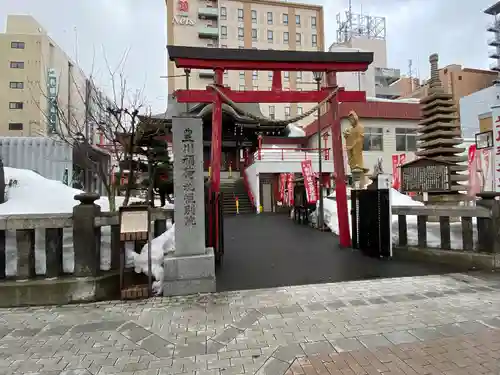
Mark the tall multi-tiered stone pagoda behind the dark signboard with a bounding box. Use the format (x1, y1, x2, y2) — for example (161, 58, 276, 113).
(416, 54, 468, 203)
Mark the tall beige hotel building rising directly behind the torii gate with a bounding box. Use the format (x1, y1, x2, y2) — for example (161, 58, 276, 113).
(167, 0, 324, 125)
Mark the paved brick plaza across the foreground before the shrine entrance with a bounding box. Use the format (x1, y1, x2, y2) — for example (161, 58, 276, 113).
(0, 274, 500, 375)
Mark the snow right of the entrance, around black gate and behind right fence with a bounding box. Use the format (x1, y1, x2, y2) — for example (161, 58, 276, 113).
(318, 189, 477, 250)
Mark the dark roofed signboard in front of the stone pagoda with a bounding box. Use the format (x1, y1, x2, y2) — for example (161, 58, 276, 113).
(401, 160, 451, 193)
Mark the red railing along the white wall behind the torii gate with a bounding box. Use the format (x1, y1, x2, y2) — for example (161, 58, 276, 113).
(249, 147, 330, 164)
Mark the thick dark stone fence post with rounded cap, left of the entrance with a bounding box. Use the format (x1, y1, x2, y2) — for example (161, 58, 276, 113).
(73, 193, 101, 277)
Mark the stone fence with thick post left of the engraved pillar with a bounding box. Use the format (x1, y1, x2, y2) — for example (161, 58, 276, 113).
(0, 194, 173, 287)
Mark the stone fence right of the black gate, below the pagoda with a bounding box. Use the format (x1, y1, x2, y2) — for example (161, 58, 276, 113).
(392, 196, 500, 254)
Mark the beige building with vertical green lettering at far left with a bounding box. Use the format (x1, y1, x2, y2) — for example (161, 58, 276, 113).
(0, 15, 105, 139)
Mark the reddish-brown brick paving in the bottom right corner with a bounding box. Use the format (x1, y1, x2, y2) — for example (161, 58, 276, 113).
(285, 329, 500, 375)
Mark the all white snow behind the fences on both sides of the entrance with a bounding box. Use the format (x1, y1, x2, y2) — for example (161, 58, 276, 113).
(0, 168, 477, 294)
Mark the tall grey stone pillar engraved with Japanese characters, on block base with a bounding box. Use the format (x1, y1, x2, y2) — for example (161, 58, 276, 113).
(163, 117, 215, 296)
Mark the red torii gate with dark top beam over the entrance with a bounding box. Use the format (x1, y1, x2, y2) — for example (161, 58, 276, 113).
(167, 46, 373, 247)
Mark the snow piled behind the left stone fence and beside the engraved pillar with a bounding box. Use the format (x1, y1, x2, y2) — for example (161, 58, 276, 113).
(0, 167, 174, 290)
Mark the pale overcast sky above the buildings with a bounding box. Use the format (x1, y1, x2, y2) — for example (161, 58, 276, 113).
(0, 0, 494, 112)
